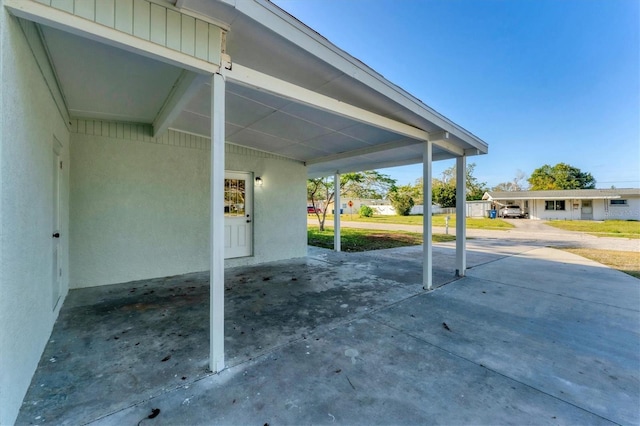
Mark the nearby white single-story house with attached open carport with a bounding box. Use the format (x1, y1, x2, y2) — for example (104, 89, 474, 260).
(0, 0, 488, 425)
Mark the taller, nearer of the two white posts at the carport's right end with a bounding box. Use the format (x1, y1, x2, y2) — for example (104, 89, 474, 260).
(422, 141, 433, 290)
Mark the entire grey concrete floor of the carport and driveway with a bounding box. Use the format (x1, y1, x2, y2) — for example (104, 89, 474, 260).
(17, 240, 640, 426)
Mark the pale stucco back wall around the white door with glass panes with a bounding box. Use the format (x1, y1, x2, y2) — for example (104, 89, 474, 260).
(70, 120, 307, 288)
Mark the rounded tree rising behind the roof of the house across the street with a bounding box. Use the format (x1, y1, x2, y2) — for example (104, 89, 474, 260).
(528, 163, 596, 191)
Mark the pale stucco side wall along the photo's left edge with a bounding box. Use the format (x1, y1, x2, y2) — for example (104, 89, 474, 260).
(0, 9, 69, 425)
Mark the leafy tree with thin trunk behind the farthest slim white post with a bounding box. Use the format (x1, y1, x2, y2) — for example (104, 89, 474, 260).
(307, 171, 396, 231)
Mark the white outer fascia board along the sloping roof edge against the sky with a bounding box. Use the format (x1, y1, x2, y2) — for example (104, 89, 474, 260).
(227, 0, 488, 153)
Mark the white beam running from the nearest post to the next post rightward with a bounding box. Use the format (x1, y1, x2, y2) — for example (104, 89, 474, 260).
(222, 63, 429, 141)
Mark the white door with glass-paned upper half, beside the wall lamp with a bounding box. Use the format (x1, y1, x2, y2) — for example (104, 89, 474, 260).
(224, 172, 253, 259)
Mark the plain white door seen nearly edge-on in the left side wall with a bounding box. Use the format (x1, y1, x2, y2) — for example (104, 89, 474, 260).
(51, 139, 62, 309)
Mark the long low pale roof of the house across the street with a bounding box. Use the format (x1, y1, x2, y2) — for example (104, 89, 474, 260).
(482, 188, 640, 200)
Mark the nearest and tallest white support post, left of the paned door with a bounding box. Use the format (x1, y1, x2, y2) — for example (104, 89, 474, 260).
(209, 74, 225, 373)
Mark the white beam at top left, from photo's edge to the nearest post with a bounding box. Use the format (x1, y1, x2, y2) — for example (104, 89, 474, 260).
(4, 0, 220, 76)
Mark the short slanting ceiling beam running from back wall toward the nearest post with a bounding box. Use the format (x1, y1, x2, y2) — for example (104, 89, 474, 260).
(153, 70, 211, 138)
